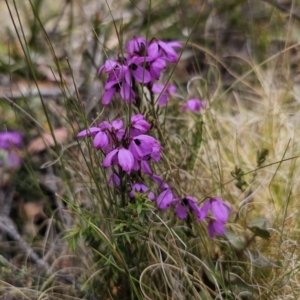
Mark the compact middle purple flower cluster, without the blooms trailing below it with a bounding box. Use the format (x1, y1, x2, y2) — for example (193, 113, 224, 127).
(77, 114, 162, 175)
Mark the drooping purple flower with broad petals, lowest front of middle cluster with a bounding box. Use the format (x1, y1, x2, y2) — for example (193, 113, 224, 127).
(103, 148, 134, 173)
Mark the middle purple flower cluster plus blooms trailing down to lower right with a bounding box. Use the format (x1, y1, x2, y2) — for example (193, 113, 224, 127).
(77, 114, 231, 237)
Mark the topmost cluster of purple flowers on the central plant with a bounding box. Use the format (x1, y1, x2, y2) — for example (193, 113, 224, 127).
(98, 37, 182, 105)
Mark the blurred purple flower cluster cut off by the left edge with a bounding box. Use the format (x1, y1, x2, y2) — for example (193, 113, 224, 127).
(0, 131, 23, 169)
